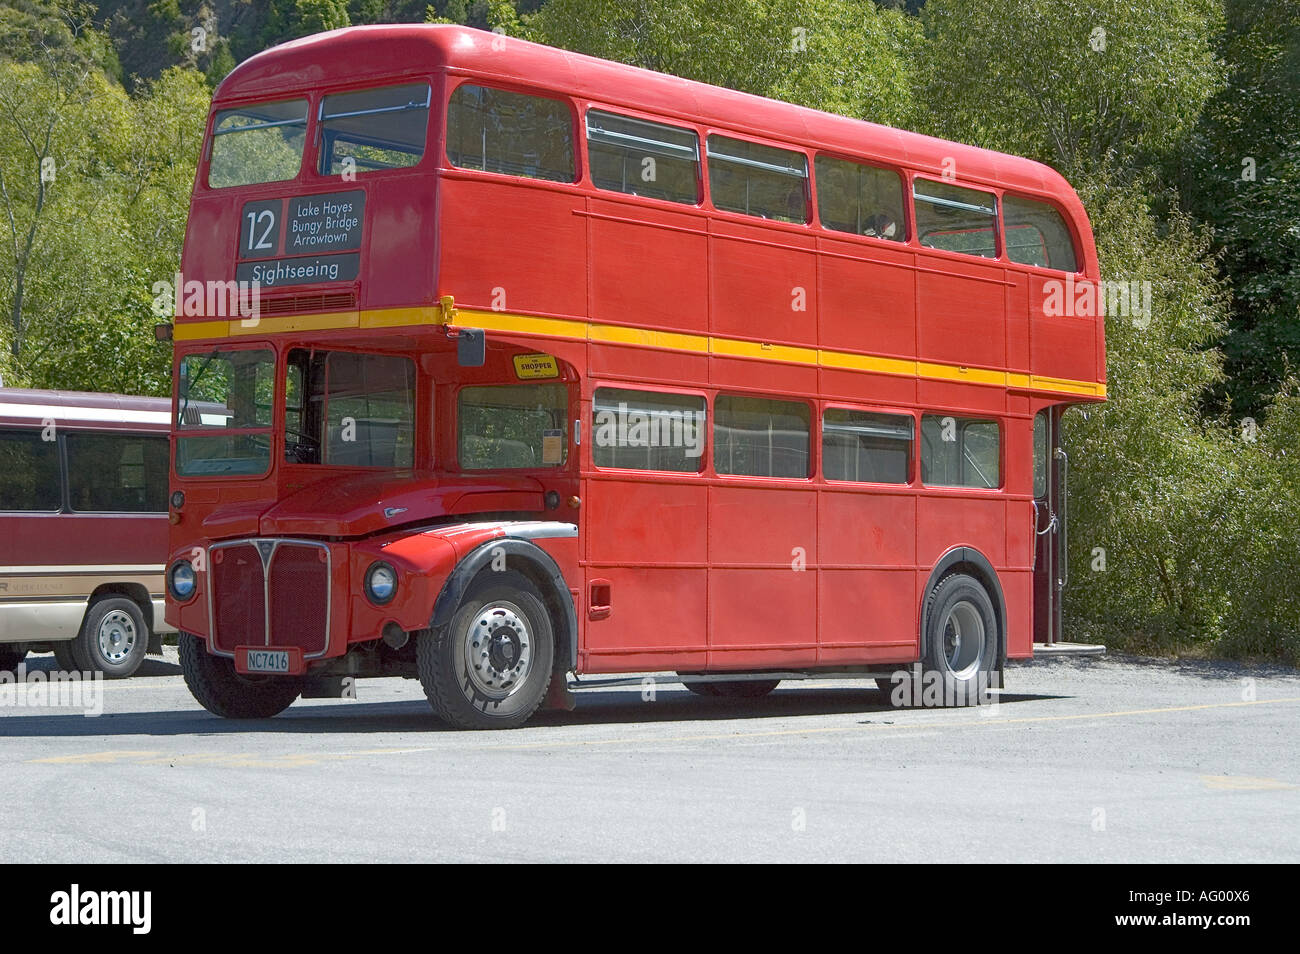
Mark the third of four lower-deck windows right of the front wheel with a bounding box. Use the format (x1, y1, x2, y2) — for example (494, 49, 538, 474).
(822, 407, 913, 483)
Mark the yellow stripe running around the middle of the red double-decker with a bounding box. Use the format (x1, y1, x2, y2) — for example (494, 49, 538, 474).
(173, 307, 1106, 398)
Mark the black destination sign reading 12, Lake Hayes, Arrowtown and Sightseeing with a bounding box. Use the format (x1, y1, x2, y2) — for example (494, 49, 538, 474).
(235, 188, 365, 287)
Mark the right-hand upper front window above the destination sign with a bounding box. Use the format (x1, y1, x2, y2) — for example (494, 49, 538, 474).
(320, 83, 430, 175)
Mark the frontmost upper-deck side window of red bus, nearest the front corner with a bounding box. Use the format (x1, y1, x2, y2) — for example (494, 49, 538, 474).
(447, 83, 577, 182)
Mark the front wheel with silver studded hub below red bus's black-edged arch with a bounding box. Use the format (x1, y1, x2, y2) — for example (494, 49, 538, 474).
(416, 571, 555, 729)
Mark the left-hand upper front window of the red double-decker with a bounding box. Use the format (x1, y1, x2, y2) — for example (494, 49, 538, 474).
(208, 99, 307, 188)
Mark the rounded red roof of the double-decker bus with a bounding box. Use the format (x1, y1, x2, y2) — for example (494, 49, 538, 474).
(213, 23, 1078, 208)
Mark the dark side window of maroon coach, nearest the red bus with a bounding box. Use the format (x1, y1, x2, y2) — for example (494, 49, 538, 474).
(68, 434, 168, 513)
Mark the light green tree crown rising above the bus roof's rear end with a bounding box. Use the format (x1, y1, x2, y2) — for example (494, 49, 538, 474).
(922, 0, 1219, 177)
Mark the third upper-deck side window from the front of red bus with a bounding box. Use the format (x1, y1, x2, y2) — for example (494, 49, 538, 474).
(709, 135, 809, 222)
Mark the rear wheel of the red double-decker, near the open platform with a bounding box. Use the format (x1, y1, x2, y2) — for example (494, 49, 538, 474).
(922, 573, 998, 706)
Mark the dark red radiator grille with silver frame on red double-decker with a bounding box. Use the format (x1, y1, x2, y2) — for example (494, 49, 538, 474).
(211, 539, 330, 656)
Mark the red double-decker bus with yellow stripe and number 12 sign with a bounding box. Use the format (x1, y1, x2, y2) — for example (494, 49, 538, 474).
(157, 26, 1105, 728)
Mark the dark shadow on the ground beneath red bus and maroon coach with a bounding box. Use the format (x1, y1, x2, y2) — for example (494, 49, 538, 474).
(0, 688, 1065, 740)
